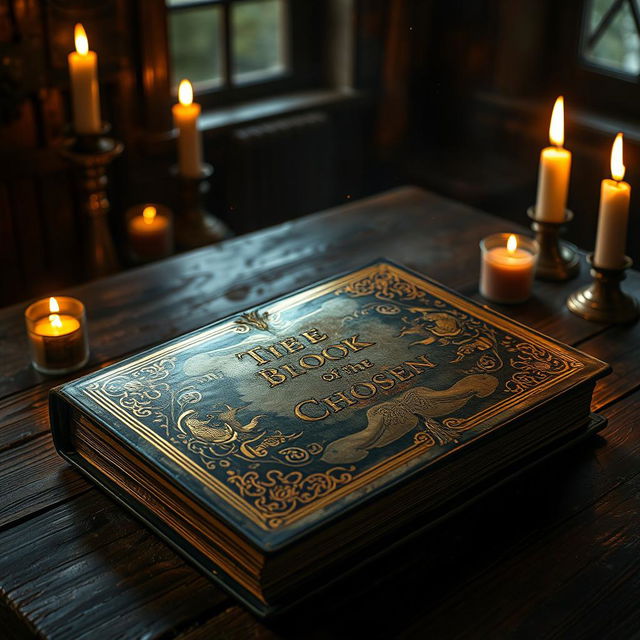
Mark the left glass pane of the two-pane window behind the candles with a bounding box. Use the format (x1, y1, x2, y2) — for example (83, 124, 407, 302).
(169, 0, 222, 86)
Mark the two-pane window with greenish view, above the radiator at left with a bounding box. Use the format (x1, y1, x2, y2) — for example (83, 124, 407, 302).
(166, 0, 290, 93)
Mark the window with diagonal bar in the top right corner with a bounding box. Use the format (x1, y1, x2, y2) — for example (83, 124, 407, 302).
(581, 0, 640, 78)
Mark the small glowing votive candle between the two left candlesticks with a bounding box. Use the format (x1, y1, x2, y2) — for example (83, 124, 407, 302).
(127, 205, 172, 260)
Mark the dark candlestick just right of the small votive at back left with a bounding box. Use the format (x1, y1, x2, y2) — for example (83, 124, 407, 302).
(171, 164, 231, 249)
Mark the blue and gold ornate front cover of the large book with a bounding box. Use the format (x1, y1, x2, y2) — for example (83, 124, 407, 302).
(62, 261, 606, 549)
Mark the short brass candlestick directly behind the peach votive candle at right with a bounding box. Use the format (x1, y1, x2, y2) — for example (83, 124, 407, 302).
(527, 207, 580, 282)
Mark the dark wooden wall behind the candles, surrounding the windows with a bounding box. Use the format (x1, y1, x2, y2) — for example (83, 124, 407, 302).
(0, 0, 640, 304)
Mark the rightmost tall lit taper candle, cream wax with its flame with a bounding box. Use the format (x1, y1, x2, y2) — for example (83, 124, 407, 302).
(593, 133, 631, 269)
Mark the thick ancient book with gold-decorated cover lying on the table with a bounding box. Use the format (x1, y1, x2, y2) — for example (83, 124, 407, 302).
(50, 260, 608, 615)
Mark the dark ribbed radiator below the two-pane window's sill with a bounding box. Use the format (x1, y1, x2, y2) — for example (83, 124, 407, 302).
(228, 112, 335, 233)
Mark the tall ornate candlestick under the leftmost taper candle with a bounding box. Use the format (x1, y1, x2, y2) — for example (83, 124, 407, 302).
(60, 125, 124, 279)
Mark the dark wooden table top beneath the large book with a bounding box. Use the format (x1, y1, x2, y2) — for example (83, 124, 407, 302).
(0, 188, 640, 640)
